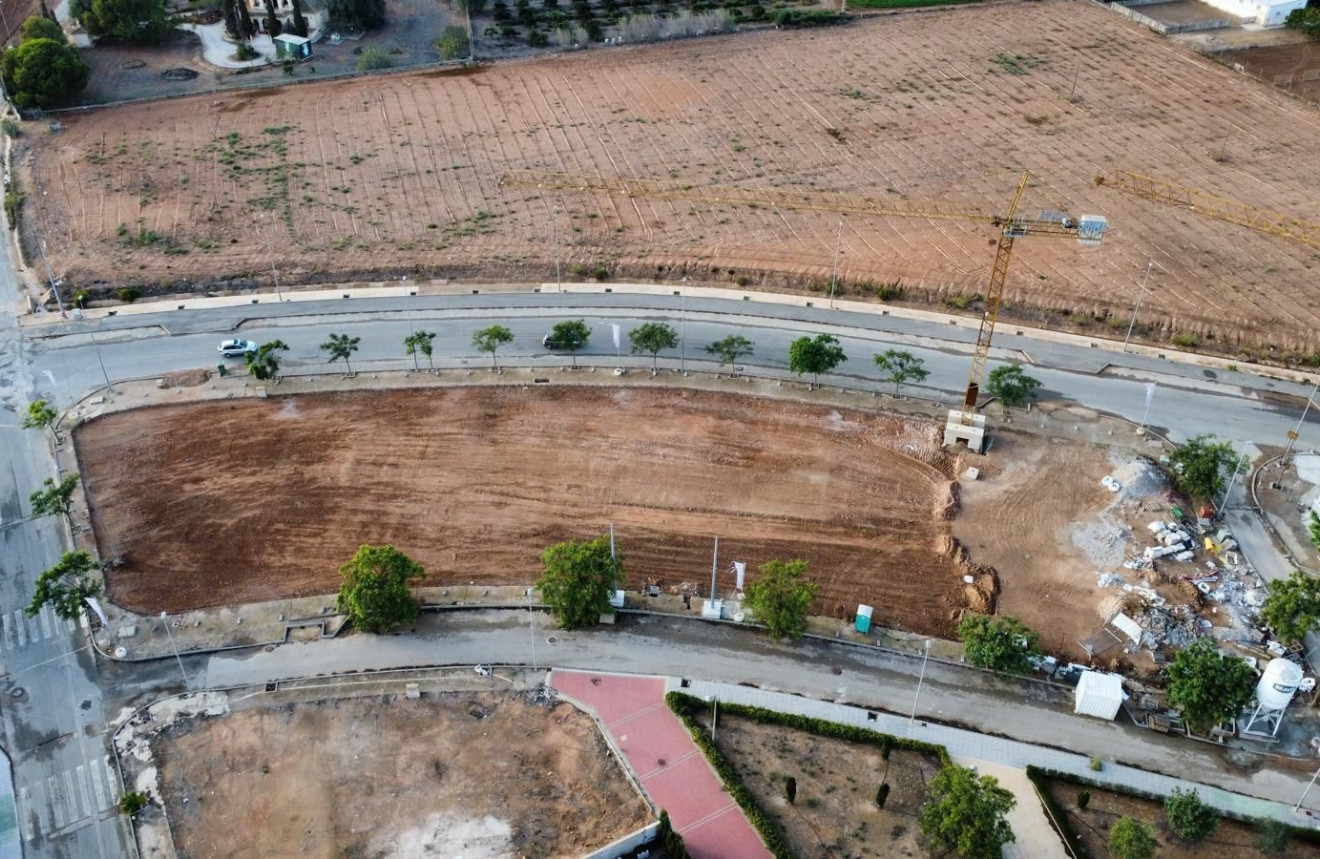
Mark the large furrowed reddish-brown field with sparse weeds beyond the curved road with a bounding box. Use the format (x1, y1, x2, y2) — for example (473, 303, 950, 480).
(25, 0, 1320, 350)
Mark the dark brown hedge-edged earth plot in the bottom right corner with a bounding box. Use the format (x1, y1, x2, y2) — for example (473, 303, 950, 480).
(1049, 781, 1320, 859)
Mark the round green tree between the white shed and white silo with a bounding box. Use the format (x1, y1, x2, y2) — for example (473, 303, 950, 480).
(1168, 639, 1255, 734)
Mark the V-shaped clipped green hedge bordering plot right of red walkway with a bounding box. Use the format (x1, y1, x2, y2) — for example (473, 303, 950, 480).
(665, 691, 949, 859)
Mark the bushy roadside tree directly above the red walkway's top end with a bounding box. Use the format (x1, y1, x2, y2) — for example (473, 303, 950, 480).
(536, 536, 623, 629)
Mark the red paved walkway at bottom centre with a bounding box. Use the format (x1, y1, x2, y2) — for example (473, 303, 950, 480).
(550, 669, 770, 859)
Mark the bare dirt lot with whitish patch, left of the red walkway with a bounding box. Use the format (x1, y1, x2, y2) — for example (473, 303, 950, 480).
(156, 694, 651, 859)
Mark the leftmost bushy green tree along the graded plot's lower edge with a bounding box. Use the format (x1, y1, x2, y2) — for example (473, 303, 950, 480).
(338, 545, 426, 633)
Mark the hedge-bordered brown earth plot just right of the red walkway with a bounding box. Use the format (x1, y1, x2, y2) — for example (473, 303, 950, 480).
(708, 715, 940, 859)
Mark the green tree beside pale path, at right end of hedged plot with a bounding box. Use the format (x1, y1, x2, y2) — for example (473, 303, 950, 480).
(919, 764, 1018, 859)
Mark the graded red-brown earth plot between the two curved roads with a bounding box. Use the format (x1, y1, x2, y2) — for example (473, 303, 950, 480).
(75, 387, 994, 636)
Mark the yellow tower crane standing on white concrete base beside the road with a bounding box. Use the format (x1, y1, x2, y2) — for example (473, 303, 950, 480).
(500, 170, 1107, 453)
